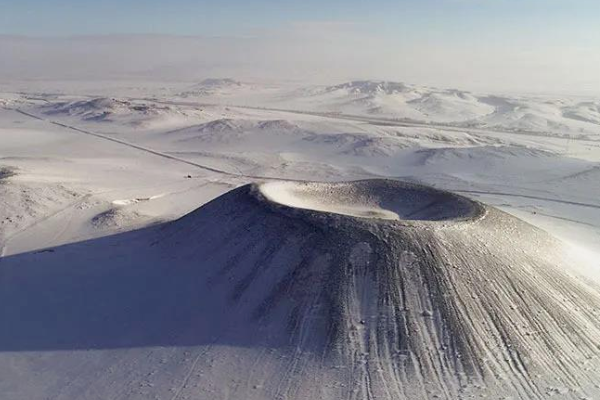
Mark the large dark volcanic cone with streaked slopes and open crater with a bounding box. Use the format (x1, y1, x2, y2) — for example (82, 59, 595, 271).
(163, 180, 600, 399)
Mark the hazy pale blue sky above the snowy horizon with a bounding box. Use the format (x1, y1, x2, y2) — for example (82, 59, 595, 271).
(0, 0, 600, 93)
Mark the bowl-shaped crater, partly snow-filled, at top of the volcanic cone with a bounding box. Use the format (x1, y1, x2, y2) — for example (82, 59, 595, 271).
(259, 179, 484, 221)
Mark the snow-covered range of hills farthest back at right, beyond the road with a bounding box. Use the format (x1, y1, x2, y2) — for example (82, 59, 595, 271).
(312, 81, 600, 134)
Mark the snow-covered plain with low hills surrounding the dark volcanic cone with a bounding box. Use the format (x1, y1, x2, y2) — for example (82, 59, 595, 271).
(0, 79, 600, 400)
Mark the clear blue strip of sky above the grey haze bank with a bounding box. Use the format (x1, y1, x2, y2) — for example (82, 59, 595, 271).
(0, 0, 600, 39)
